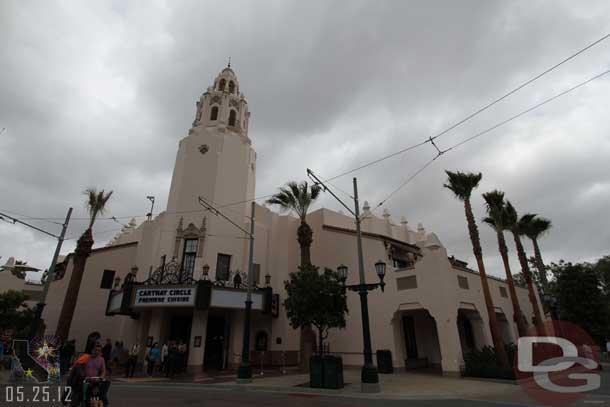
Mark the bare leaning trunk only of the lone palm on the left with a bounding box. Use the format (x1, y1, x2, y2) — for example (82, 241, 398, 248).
(55, 228, 93, 342)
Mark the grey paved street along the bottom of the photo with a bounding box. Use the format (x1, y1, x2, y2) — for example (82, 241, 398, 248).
(0, 370, 610, 407)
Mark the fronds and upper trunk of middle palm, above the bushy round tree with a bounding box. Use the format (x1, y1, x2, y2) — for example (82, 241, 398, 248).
(267, 181, 321, 266)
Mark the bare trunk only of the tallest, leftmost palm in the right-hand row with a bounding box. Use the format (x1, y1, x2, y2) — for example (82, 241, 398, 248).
(464, 199, 510, 368)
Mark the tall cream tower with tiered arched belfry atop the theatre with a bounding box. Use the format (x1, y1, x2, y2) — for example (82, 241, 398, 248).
(158, 64, 256, 272)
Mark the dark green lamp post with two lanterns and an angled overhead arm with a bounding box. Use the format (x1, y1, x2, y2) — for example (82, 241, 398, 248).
(307, 168, 385, 393)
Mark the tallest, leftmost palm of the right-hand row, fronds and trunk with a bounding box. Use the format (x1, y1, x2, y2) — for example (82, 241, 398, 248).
(444, 171, 510, 368)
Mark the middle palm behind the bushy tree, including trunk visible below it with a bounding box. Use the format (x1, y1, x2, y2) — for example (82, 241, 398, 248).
(267, 181, 321, 372)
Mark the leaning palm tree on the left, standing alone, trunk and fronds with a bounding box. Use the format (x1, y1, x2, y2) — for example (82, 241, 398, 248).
(55, 188, 112, 341)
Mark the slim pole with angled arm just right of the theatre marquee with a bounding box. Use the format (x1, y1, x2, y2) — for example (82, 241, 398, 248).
(199, 197, 256, 384)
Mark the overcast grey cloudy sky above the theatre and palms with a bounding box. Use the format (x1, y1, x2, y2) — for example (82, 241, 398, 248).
(0, 0, 610, 282)
